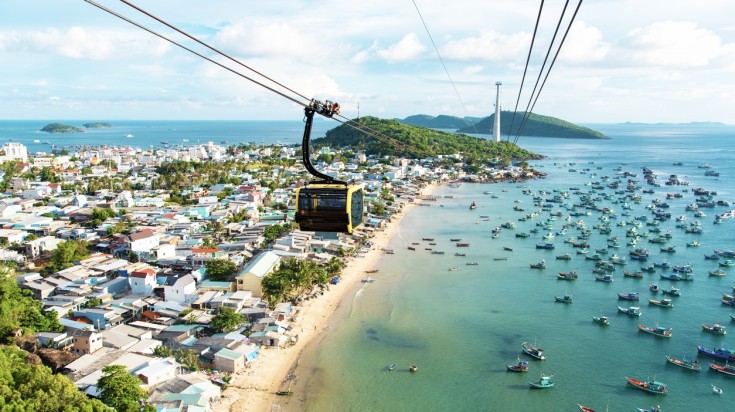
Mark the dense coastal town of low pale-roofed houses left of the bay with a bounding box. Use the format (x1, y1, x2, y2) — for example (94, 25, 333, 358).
(0, 142, 533, 412)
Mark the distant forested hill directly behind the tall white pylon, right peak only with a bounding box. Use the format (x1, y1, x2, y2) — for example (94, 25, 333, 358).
(459, 111, 607, 139)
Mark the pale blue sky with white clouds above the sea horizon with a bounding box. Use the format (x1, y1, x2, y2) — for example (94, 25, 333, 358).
(0, 0, 735, 124)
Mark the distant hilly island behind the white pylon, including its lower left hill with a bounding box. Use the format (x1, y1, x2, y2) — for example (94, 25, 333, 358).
(401, 111, 607, 140)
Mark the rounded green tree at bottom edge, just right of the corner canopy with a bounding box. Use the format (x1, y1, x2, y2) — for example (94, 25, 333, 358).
(97, 365, 148, 411)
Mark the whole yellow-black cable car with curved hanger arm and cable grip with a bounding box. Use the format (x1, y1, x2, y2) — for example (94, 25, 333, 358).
(294, 100, 364, 233)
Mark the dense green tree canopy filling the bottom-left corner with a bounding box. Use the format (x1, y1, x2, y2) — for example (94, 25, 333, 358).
(0, 346, 113, 412)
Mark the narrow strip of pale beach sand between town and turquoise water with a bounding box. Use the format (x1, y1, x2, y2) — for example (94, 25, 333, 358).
(213, 184, 437, 412)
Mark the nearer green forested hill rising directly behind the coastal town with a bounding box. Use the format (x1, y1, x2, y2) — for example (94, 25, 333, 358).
(313, 117, 541, 162)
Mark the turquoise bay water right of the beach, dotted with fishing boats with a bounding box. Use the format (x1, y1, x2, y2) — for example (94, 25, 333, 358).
(275, 125, 735, 411)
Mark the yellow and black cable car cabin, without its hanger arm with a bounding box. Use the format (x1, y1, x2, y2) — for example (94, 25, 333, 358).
(295, 184, 364, 233)
